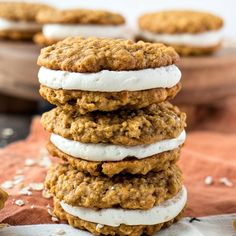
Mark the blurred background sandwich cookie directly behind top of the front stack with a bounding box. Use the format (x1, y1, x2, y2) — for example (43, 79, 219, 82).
(35, 9, 127, 46)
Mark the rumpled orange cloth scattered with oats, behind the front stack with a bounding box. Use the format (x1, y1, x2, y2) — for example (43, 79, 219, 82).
(0, 118, 236, 225)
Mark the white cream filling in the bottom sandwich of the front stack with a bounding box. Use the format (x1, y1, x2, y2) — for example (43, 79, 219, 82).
(61, 186, 187, 227)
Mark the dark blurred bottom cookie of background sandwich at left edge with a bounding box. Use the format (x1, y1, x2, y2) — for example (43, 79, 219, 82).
(0, 30, 36, 40)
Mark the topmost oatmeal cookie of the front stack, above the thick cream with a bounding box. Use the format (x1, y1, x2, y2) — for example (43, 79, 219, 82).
(38, 37, 179, 73)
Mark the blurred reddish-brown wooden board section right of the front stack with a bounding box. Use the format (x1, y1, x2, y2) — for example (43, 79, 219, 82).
(175, 47, 236, 105)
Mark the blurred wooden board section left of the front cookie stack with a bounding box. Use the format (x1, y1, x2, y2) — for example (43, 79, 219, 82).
(0, 41, 40, 100)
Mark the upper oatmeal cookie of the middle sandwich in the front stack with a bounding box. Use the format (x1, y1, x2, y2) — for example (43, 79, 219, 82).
(41, 102, 186, 146)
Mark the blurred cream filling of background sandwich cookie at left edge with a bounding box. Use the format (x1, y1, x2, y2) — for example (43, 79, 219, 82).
(0, 18, 41, 31)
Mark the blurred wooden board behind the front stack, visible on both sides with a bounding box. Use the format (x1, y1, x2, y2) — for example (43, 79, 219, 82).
(0, 41, 236, 105)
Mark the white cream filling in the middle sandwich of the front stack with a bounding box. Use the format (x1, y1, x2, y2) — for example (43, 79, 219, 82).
(50, 131, 186, 161)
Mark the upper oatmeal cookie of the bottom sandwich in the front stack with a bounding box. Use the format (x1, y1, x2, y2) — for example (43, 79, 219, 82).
(45, 163, 182, 209)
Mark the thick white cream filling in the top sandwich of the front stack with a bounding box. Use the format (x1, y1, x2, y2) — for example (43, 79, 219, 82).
(38, 65, 181, 92)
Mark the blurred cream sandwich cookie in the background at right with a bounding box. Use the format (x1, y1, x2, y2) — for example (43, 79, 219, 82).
(137, 10, 223, 56)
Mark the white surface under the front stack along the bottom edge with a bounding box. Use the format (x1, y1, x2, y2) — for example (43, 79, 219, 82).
(0, 214, 236, 236)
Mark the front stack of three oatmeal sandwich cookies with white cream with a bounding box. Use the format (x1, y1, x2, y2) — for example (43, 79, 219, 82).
(38, 38, 187, 235)
